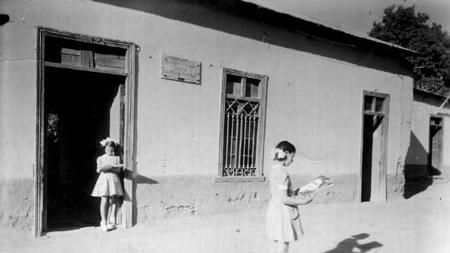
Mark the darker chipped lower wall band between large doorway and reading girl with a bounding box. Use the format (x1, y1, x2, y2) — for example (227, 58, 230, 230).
(135, 176, 270, 223)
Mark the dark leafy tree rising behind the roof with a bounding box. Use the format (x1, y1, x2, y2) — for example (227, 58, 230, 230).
(369, 5, 450, 94)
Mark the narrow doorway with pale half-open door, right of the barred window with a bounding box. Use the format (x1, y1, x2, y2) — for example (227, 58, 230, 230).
(361, 93, 388, 202)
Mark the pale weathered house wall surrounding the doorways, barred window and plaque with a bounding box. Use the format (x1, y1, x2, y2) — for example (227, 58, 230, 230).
(0, 0, 412, 233)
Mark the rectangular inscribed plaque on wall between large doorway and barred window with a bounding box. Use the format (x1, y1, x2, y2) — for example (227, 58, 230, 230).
(161, 55, 201, 84)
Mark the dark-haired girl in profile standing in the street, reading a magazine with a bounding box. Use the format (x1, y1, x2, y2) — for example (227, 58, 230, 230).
(266, 141, 317, 253)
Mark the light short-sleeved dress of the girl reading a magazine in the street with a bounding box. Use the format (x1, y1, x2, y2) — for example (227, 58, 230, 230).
(266, 164, 303, 242)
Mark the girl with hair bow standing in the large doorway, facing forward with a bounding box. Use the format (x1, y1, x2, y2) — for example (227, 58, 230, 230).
(91, 137, 123, 231)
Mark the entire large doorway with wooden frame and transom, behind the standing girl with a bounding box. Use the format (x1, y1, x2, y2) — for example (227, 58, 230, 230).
(35, 28, 137, 236)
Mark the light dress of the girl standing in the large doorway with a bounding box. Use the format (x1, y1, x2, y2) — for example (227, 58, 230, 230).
(91, 154, 123, 197)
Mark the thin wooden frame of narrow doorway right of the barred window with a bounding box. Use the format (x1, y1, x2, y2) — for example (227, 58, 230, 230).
(357, 90, 390, 202)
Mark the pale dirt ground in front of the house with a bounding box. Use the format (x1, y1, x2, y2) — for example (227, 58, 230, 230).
(0, 183, 450, 253)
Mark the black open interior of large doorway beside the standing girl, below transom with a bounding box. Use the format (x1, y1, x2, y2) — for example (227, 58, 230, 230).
(45, 68, 125, 230)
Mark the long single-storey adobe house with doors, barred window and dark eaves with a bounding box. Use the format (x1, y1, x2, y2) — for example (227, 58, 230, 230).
(0, 0, 413, 236)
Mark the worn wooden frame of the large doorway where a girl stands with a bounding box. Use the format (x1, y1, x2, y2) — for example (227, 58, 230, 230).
(34, 27, 138, 237)
